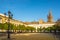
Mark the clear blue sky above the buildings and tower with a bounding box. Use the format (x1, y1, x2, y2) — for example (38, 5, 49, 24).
(0, 0, 60, 22)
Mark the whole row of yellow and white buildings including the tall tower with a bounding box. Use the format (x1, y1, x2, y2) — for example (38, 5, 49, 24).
(0, 11, 55, 29)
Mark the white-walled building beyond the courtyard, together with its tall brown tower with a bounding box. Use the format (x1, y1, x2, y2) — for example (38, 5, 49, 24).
(24, 10, 55, 29)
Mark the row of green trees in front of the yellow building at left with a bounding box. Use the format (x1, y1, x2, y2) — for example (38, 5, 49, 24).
(0, 23, 36, 32)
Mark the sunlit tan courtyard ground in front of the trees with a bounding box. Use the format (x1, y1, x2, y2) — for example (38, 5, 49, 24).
(0, 33, 59, 40)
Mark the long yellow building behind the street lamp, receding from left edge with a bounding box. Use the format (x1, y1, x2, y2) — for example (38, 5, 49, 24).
(0, 14, 23, 25)
